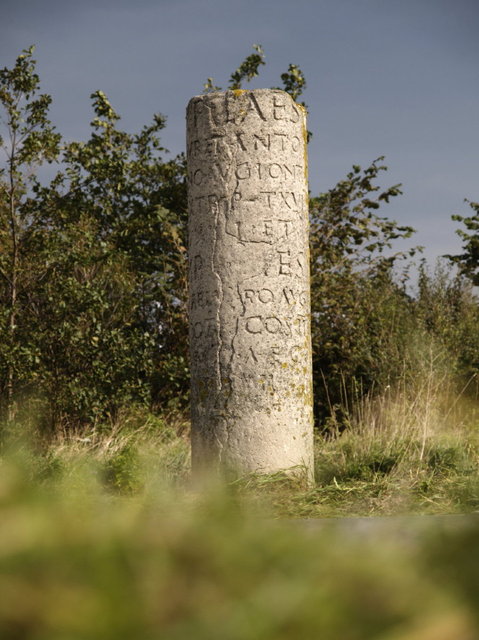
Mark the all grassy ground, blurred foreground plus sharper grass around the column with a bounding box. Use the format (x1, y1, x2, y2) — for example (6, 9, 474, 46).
(0, 378, 479, 640)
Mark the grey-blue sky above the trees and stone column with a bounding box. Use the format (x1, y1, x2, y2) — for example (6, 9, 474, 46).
(0, 0, 479, 272)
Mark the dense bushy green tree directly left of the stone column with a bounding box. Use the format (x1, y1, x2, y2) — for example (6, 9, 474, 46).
(25, 86, 187, 425)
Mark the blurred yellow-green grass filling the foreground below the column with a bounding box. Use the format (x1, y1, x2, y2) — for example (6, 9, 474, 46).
(0, 432, 479, 640)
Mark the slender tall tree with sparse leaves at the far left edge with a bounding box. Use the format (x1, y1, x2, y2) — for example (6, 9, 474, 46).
(0, 47, 60, 420)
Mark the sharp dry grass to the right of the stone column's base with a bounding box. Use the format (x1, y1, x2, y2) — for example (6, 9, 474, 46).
(229, 372, 479, 518)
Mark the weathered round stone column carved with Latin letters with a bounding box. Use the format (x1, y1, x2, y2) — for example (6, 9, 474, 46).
(187, 89, 313, 479)
